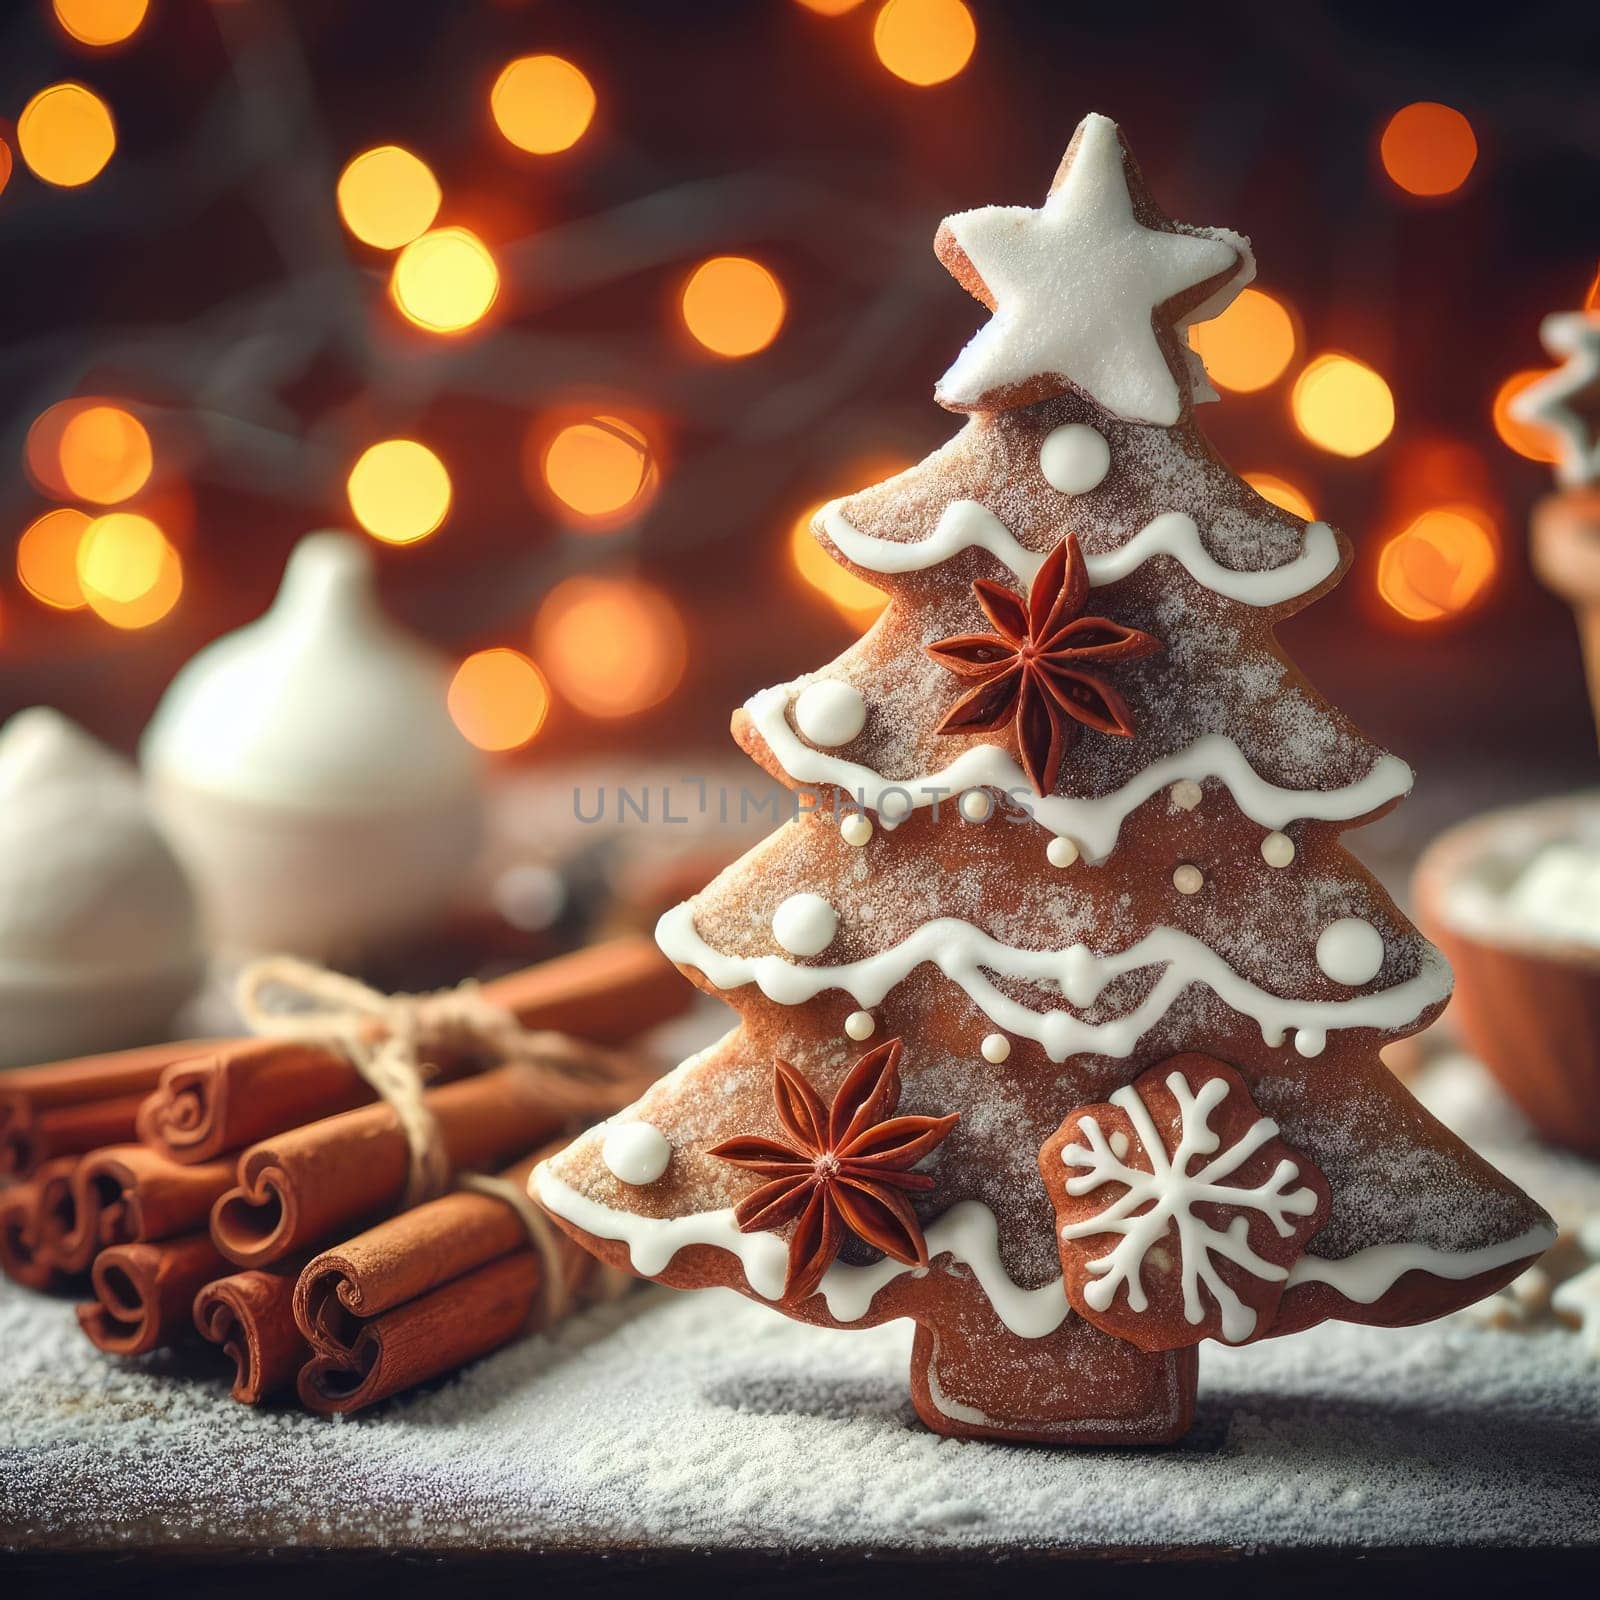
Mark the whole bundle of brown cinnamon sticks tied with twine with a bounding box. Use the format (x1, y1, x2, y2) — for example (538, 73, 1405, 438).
(0, 938, 688, 1413)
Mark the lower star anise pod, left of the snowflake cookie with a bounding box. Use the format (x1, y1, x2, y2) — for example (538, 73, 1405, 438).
(710, 1038, 960, 1301)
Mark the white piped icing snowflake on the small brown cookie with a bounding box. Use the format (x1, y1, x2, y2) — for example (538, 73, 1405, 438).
(1061, 1072, 1317, 1344)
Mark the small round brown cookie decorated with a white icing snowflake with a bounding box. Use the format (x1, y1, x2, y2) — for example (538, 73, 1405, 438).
(1040, 1054, 1328, 1350)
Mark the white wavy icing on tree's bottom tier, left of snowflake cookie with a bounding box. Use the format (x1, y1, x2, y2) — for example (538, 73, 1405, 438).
(531, 1162, 1070, 1339)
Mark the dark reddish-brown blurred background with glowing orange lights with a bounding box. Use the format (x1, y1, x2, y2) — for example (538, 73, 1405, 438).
(0, 0, 1600, 857)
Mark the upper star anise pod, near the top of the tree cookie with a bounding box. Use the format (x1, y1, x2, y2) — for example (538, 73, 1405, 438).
(923, 533, 1163, 795)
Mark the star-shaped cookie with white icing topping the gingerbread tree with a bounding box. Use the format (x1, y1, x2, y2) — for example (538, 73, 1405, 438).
(936, 114, 1254, 427)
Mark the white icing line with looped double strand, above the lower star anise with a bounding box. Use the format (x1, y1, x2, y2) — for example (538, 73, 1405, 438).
(656, 901, 1450, 1061)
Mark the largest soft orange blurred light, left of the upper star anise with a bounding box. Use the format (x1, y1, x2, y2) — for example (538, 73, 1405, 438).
(533, 576, 688, 717)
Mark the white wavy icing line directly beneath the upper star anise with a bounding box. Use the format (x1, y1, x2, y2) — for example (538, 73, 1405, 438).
(744, 683, 1411, 866)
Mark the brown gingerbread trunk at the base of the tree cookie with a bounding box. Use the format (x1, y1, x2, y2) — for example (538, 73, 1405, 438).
(910, 1294, 1198, 1445)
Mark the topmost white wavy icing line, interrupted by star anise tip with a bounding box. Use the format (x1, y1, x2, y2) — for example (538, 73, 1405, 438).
(821, 501, 1339, 606)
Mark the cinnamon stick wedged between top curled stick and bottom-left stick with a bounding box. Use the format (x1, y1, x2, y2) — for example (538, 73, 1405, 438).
(40, 1144, 234, 1272)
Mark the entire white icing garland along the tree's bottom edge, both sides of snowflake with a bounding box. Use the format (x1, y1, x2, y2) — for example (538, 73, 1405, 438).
(530, 1163, 1555, 1339)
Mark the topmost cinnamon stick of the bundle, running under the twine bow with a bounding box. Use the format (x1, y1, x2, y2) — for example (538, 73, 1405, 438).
(139, 938, 688, 1162)
